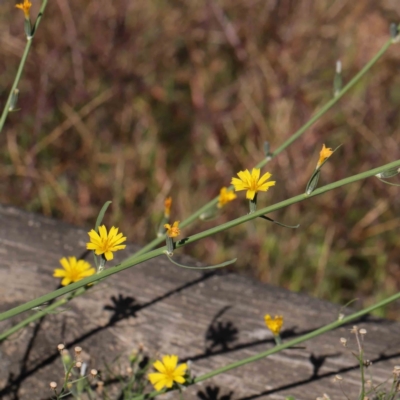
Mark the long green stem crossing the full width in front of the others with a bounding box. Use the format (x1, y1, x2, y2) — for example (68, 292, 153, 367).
(0, 160, 400, 321)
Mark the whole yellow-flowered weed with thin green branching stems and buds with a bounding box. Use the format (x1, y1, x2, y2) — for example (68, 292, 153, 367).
(0, 0, 400, 400)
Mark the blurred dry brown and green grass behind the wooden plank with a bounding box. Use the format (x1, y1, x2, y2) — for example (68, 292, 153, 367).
(0, 0, 400, 318)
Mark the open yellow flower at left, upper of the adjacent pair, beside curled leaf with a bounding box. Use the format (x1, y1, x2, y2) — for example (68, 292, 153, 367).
(86, 225, 126, 261)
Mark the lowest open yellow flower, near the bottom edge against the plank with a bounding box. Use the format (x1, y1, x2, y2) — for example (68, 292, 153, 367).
(148, 354, 187, 390)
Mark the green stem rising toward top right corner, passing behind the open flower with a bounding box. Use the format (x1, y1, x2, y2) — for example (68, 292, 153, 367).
(129, 39, 392, 257)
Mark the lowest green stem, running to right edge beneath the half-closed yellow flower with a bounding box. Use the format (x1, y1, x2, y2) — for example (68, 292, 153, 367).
(132, 293, 400, 400)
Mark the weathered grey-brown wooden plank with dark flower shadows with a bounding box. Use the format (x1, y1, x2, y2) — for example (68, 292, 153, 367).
(0, 206, 400, 400)
